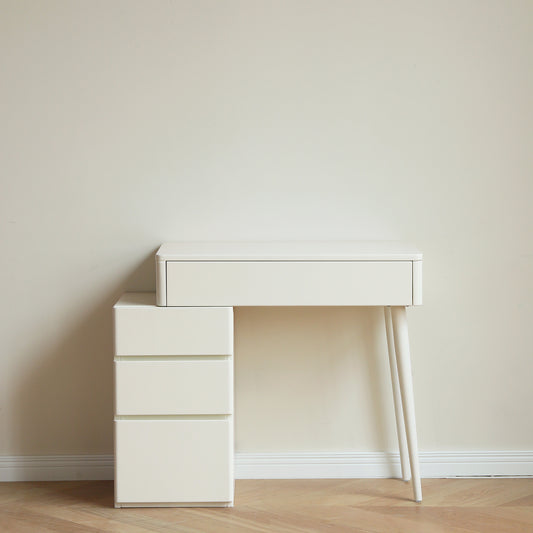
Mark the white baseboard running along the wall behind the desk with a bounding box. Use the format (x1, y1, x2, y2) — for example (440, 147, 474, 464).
(0, 451, 533, 481)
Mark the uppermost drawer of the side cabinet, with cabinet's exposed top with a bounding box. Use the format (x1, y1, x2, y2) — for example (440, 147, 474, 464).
(114, 293, 233, 356)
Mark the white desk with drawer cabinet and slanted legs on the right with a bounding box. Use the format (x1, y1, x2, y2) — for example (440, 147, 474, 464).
(115, 241, 422, 507)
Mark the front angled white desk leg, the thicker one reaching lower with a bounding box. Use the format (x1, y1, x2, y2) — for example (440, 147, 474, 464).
(391, 307, 422, 502)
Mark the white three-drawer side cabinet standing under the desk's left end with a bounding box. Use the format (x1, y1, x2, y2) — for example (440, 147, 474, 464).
(114, 293, 233, 507)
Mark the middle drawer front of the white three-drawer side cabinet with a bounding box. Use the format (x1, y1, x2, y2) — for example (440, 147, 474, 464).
(115, 358, 233, 415)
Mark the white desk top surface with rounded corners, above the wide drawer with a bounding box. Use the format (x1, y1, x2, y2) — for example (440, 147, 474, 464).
(156, 241, 422, 261)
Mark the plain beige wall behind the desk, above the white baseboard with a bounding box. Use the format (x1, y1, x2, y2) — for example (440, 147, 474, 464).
(0, 0, 533, 455)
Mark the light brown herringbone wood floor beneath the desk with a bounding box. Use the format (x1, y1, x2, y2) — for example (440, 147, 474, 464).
(0, 479, 533, 533)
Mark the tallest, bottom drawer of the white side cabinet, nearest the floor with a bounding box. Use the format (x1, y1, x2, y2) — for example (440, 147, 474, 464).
(115, 418, 233, 505)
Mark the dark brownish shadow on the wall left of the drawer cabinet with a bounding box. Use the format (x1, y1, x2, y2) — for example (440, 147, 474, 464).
(10, 250, 155, 455)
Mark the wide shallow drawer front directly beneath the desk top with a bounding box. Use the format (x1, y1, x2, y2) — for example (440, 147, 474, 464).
(166, 261, 413, 306)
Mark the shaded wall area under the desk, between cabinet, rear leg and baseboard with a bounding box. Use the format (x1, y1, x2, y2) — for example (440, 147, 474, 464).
(235, 307, 397, 452)
